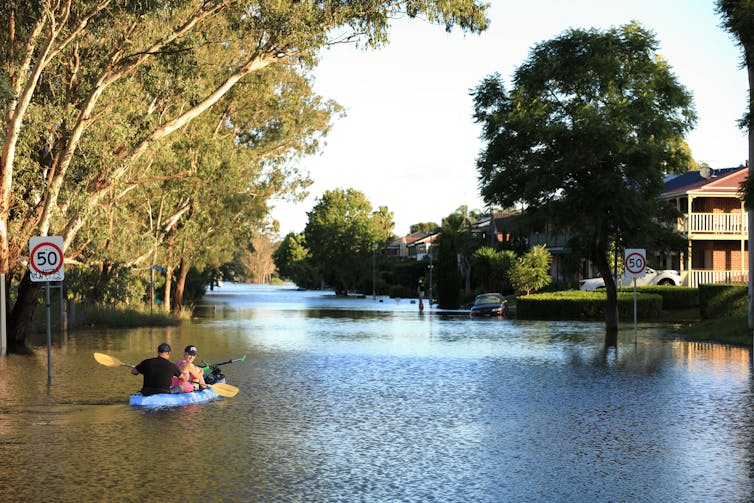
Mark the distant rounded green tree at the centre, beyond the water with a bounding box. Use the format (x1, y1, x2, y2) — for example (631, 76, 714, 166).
(304, 189, 385, 295)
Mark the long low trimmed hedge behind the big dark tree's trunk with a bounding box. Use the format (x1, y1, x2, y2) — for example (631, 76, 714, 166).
(516, 290, 662, 320)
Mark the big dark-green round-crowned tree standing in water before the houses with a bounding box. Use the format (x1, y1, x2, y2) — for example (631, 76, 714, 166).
(473, 23, 695, 342)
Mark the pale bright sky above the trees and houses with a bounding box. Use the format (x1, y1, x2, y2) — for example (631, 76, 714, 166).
(270, 0, 748, 236)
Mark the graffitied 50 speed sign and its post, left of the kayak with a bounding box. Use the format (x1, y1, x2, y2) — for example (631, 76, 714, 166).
(29, 236, 65, 384)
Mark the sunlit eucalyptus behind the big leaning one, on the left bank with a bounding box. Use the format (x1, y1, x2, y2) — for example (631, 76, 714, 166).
(118, 67, 339, 314)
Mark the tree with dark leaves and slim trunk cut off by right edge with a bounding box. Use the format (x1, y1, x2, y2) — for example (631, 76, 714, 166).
(717, 0, 754, 330)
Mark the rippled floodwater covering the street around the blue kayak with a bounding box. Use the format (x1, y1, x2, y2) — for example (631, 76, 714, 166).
(0, 284, 754, 502)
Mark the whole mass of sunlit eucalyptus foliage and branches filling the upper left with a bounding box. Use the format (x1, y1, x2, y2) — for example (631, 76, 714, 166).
(0, 0, 488, 339)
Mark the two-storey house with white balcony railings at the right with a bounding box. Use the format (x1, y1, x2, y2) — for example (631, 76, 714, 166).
(660, 166, 749, 286)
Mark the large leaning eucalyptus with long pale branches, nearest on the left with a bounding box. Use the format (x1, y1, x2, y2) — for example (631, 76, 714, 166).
(0, 0, 487, 350)
